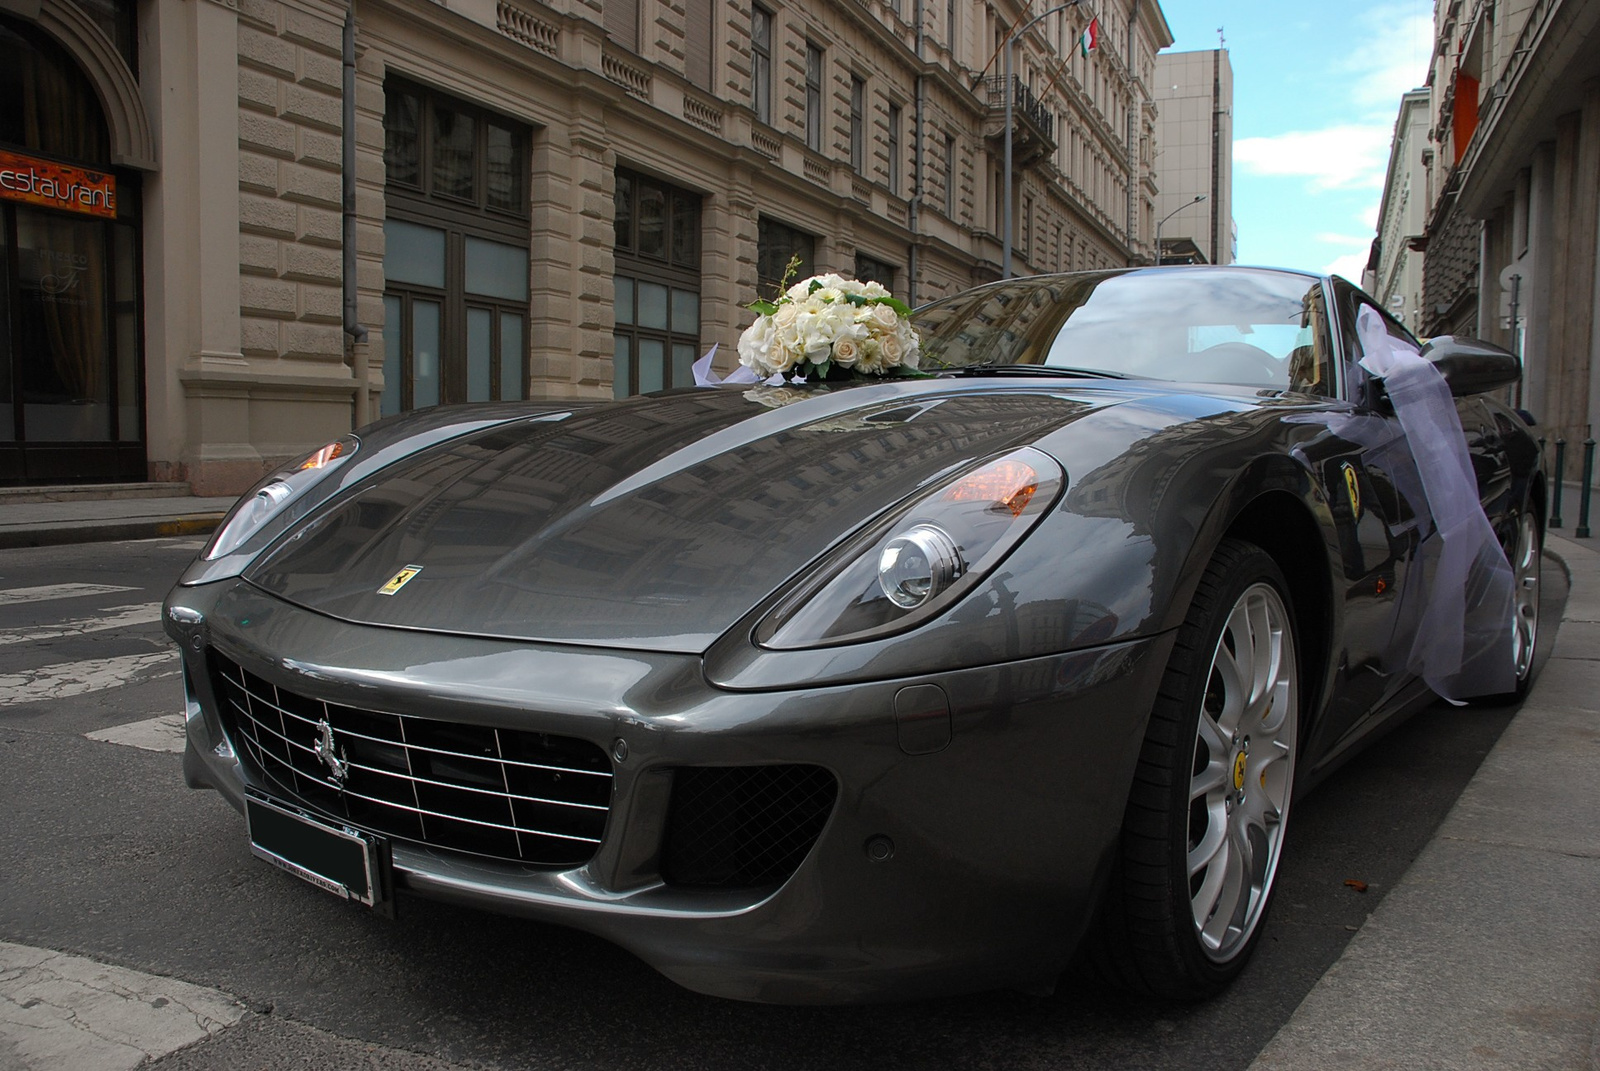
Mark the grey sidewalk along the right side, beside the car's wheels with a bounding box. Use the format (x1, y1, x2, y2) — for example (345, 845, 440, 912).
(1251, 533, 1600, 1071)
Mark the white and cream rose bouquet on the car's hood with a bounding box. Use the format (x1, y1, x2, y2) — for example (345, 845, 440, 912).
(739, 263, 920, 381)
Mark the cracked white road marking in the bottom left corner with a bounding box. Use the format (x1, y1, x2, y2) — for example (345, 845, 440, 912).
(0, 941, 245, 1071)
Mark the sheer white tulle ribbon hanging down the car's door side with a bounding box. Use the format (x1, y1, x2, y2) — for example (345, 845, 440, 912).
(1355, 307, 1517, 700)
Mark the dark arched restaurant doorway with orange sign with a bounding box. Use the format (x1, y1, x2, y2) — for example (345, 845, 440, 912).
(0, 16, 146, 483)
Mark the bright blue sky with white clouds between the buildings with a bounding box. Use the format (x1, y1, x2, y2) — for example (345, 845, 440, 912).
(1162, 0, 1434, 283)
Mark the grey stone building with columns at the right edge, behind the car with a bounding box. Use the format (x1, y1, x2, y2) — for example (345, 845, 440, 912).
(1421, 0, 1600, 451)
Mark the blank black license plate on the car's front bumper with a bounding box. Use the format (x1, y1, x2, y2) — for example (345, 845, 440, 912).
(245, 792, 394, 914)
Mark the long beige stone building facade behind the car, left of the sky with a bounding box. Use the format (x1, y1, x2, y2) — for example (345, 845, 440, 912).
(0, 0, 1171, 493)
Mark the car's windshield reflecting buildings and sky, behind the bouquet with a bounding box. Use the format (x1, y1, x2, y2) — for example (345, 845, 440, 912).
(915, 267, 1331, 394)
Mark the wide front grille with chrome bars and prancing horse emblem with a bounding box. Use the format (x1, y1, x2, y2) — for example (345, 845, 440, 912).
(210, 650, 611, 869)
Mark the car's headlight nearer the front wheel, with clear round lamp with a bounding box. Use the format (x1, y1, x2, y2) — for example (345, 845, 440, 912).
(755, 448, 1066, 650)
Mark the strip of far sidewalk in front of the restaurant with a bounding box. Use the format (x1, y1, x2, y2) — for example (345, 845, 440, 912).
(0, 485, 235, 549)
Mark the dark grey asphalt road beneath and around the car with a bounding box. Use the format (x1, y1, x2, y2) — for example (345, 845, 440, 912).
(0, 540, 1566, 1071)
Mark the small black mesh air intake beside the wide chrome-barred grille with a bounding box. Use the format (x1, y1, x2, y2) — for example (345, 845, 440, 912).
(661, 765, 838, 887)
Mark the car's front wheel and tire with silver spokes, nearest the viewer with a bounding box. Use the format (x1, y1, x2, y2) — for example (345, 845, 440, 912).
(1090, 540, 1301, 1001)
